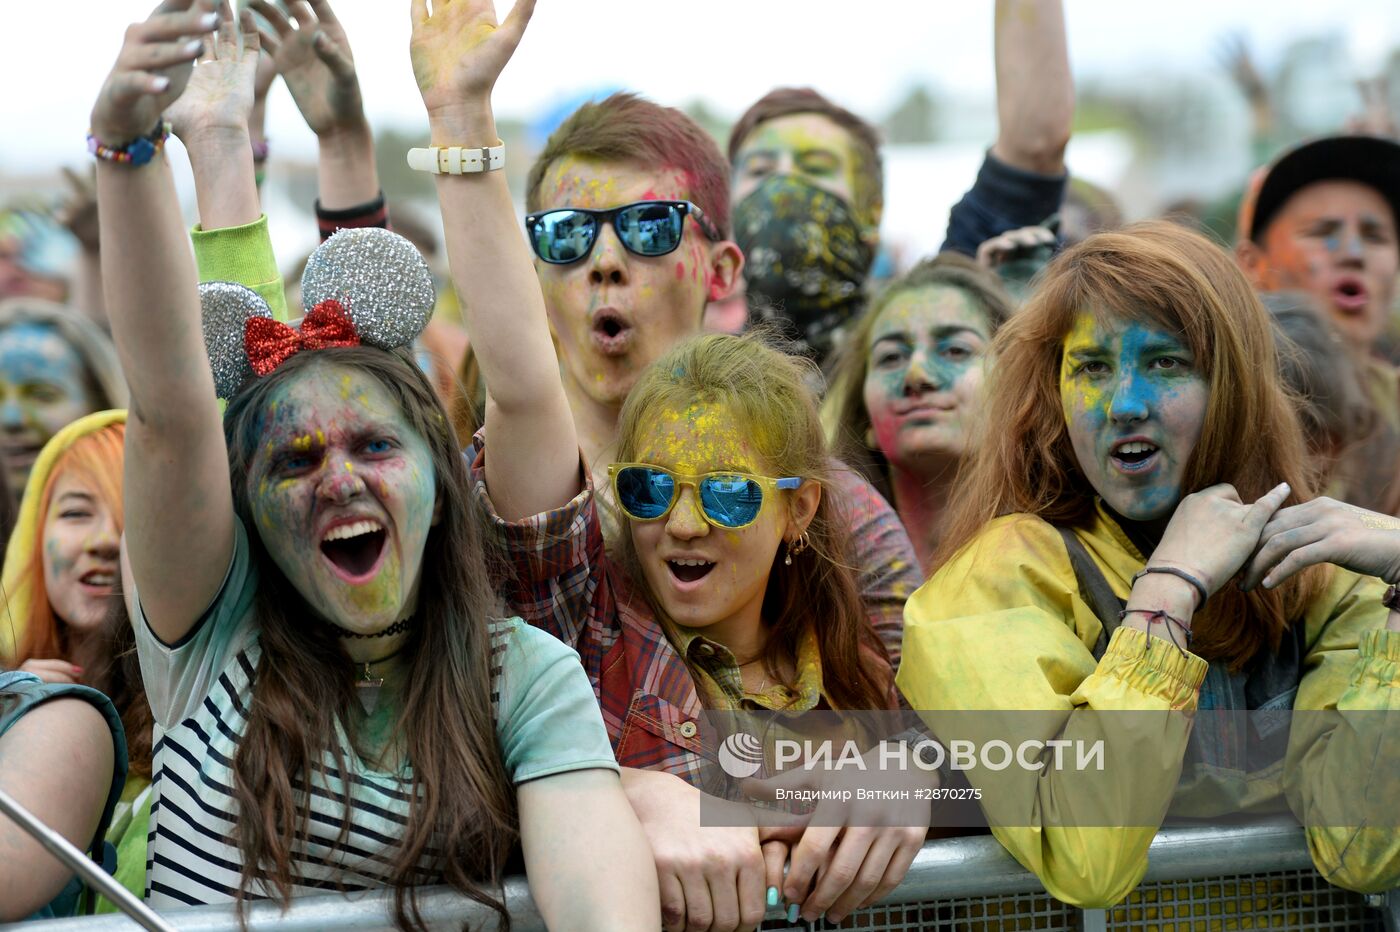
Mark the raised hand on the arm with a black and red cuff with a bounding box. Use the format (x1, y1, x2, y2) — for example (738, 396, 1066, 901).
(248, 0, 365, 136)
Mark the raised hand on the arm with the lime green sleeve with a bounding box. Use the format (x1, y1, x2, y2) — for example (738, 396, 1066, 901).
(165, 0, 260, 144)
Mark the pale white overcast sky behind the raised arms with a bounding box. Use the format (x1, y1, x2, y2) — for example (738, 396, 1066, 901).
(0, 0, 1400, 171)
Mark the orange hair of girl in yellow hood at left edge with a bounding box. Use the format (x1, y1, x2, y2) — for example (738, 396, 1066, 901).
(14, 424, 126, 666)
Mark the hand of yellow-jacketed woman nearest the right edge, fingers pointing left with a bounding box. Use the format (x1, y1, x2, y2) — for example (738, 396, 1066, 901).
(1242, 498, 1400, 589)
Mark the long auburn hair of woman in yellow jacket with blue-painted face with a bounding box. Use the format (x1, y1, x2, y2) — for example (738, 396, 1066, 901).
(934, 221, 1329, 669)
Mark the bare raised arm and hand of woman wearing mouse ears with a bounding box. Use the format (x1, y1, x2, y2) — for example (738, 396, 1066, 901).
(91, 0, 234, 644)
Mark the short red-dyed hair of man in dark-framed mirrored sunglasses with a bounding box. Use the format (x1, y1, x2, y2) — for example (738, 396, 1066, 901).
(525, 94, 729, 236)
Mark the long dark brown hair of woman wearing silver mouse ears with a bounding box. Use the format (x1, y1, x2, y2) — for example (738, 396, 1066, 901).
(224, 347, 519, 929)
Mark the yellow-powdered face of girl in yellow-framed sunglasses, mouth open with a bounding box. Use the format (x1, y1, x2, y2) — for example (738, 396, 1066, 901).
(629, 403, 820, 644)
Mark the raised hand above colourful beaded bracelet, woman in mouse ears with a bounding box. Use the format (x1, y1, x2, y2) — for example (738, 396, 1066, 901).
(88, 0, 218, 146)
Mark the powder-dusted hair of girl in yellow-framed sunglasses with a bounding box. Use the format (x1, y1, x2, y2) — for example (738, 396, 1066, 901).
(617, 333, 895, 709)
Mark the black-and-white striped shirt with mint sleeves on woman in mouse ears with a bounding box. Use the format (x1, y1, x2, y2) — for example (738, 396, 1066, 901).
(130, 514, 617, 908)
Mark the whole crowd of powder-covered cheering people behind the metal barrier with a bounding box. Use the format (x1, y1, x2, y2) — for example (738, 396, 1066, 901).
(0, 0, 1400, 931)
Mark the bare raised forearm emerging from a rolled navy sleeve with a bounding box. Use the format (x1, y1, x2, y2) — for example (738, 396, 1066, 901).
(991, 0, 1074, 175)
